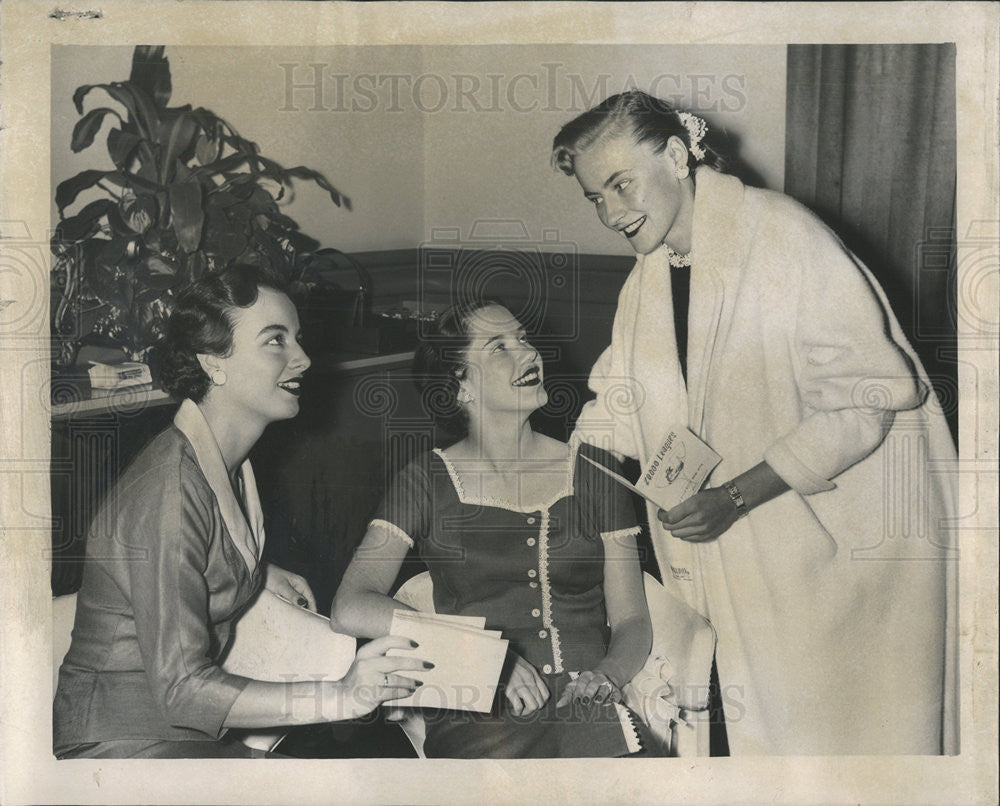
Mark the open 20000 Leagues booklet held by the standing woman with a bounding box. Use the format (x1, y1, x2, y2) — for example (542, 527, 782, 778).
(584, 425, 722, 510)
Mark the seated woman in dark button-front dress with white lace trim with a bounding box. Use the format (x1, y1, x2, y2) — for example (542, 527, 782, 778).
(332, 303, 660, 758)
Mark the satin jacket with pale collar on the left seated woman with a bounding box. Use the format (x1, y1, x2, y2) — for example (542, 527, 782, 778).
(53, 400, 264, 754)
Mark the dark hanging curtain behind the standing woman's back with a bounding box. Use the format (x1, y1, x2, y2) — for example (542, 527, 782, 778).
(785, 44, 958, 435)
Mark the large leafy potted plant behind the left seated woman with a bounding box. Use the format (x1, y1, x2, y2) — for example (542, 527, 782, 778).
(51, 46, 350, 370)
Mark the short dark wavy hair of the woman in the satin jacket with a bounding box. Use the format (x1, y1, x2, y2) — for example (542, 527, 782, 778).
(159, 265, 287, 403)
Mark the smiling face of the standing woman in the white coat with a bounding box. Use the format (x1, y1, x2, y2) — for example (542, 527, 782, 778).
(573, 134, 694, 255)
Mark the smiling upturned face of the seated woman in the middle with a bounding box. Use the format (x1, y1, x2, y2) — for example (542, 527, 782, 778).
(461, 305, 548, 415)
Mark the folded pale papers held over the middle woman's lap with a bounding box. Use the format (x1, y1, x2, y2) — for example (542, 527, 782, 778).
(388, 610, 507, 713)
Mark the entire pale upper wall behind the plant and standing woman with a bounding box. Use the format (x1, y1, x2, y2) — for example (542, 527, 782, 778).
(52, 45, 785, 254)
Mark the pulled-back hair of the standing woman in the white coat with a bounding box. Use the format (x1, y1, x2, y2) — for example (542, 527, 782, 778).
(551, 90, 725, 176)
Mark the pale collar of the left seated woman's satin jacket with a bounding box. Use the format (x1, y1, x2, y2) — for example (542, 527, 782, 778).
(174, 400, 264, 574)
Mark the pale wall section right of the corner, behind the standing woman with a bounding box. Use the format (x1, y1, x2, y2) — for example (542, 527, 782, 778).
(423, 45, 785, 254)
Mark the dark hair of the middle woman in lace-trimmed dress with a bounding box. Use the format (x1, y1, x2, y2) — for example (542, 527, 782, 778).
(413, 297, 509, 439)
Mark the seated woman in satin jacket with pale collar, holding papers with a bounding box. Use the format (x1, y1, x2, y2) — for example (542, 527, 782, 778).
(53, 266, 422, 758)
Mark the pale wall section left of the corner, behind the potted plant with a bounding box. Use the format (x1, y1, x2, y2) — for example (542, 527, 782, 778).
(52, 47, 423, 251)
